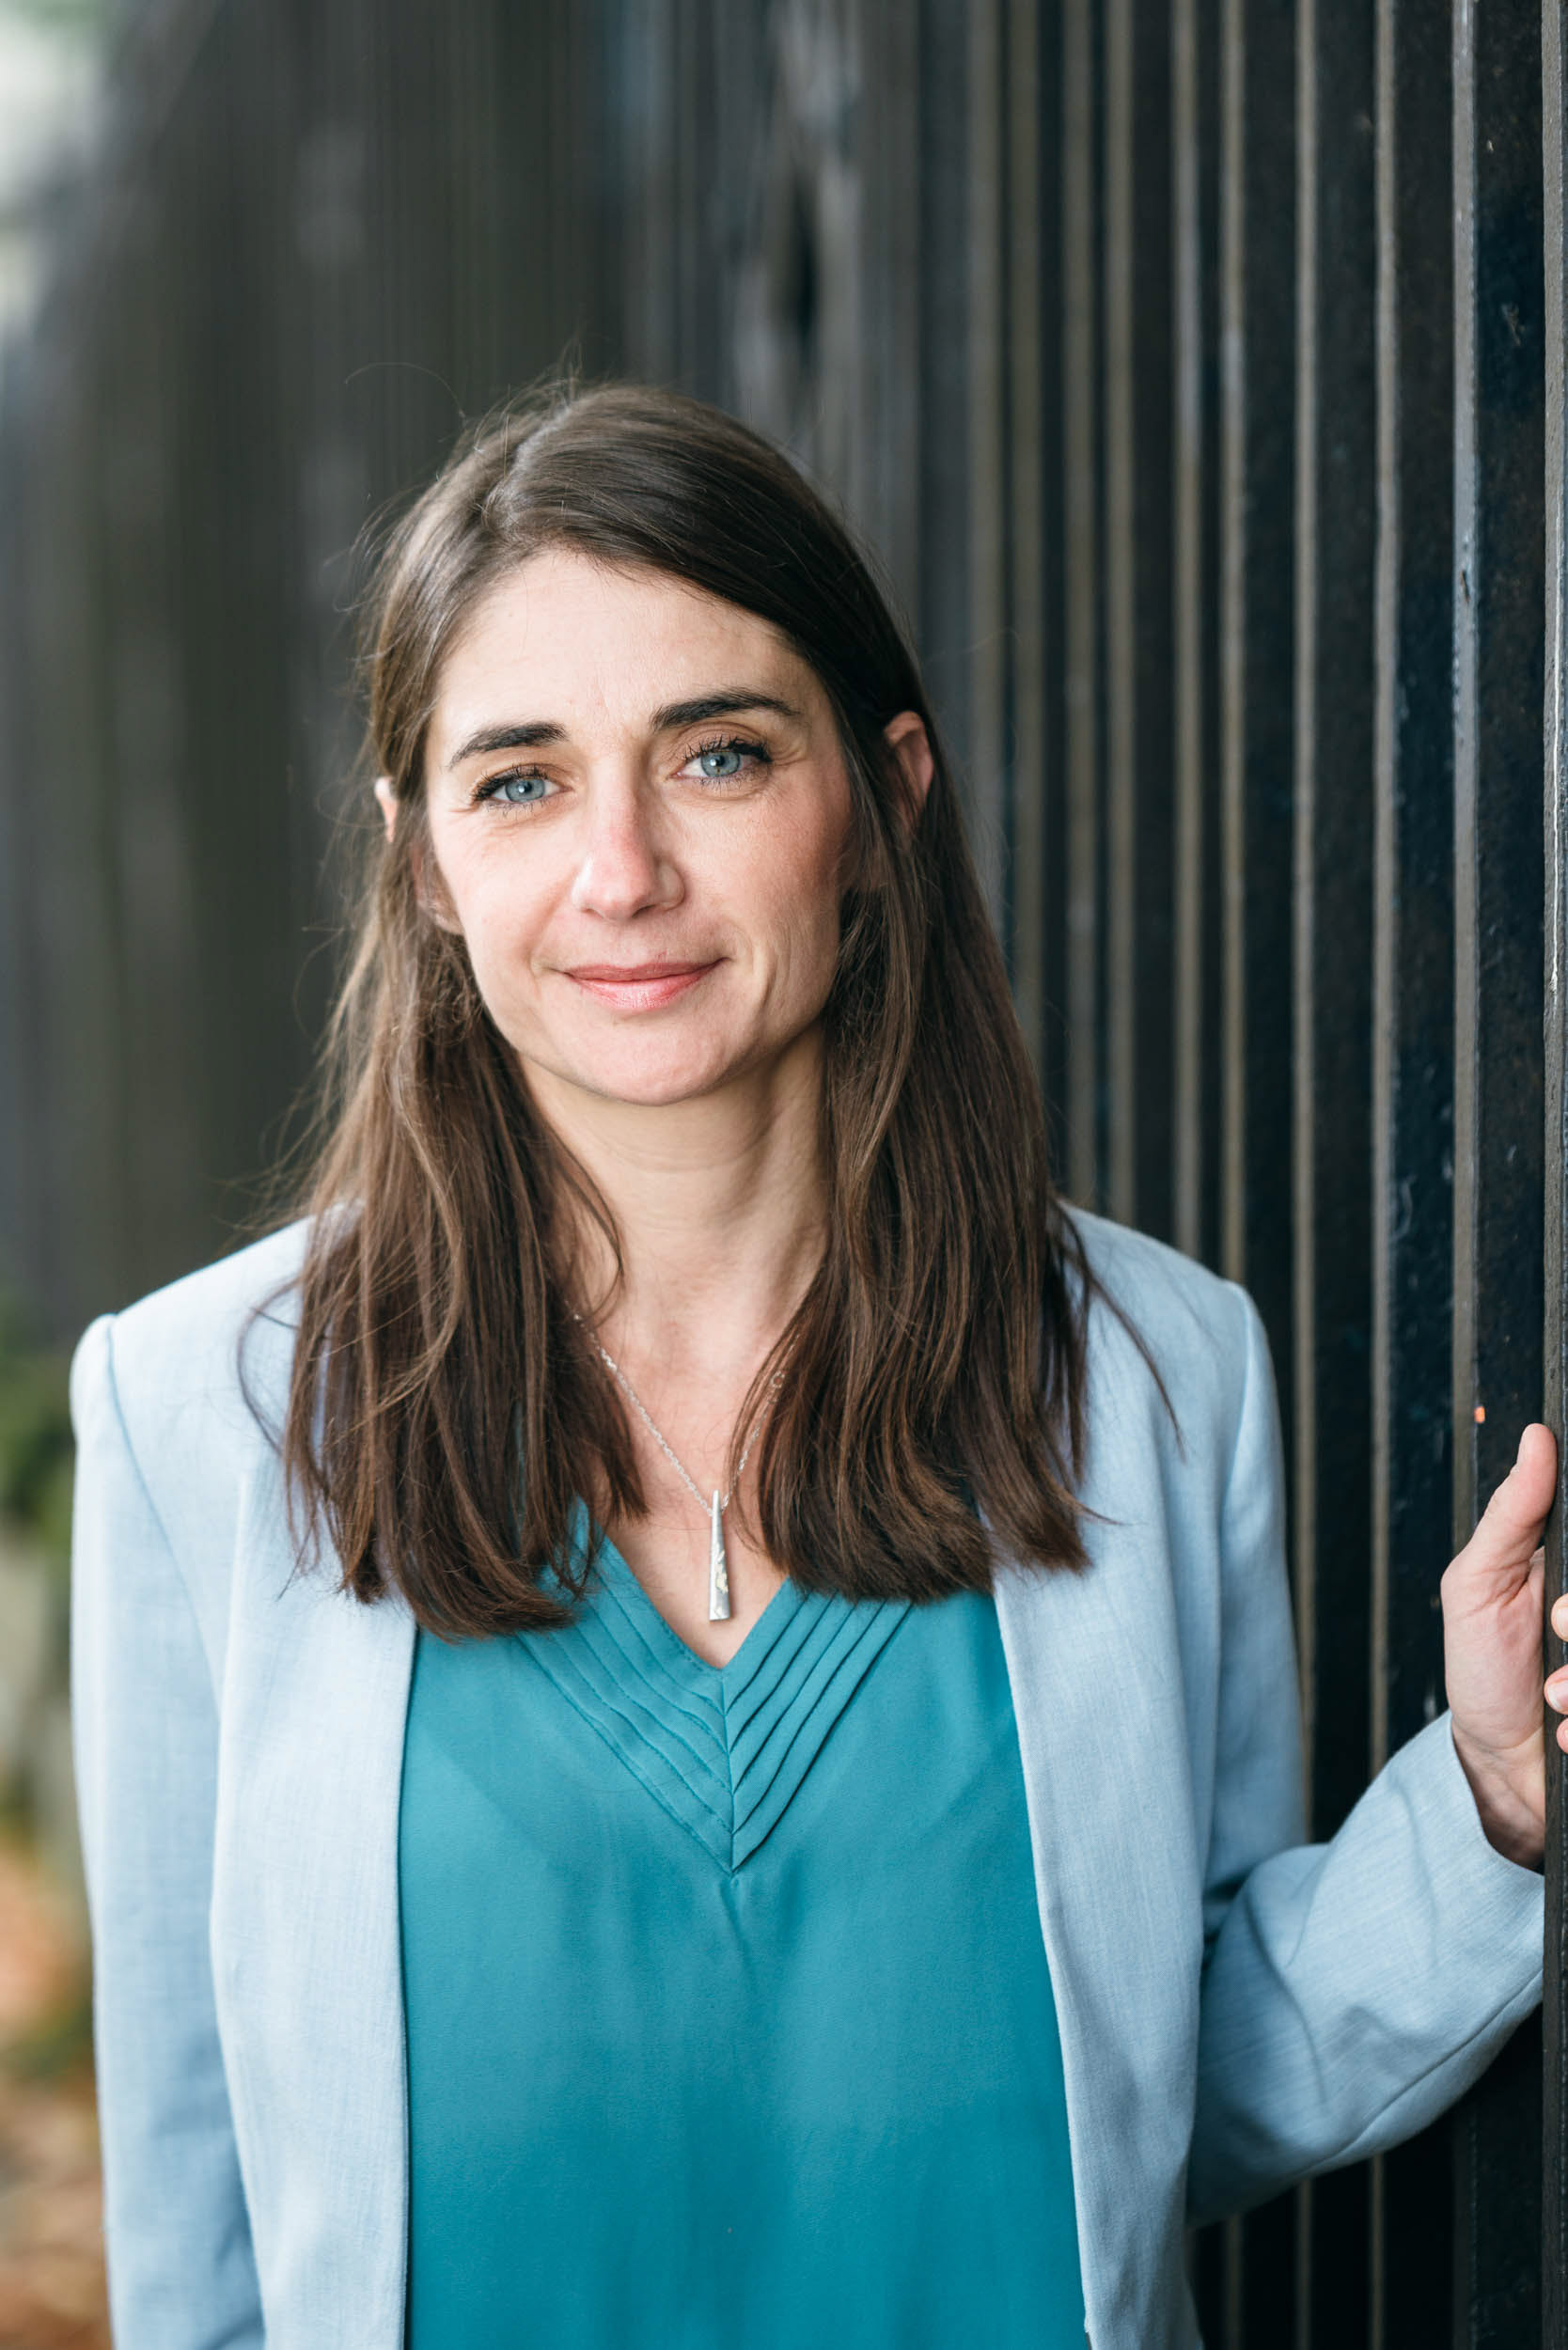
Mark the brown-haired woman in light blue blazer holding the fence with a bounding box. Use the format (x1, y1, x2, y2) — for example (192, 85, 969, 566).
(75, 388, 1568, 2350)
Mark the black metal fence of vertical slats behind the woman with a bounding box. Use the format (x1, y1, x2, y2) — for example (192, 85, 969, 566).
(0, 0, 1568, 2350)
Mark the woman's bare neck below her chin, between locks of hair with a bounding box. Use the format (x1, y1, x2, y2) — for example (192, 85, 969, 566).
(529, 1032, 827, 1382)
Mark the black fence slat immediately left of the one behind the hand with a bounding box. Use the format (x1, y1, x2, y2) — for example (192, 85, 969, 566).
(1371, 0, 1452, 2350)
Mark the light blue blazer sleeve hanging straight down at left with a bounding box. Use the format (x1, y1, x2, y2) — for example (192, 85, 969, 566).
(71, 1316, 263, 2350)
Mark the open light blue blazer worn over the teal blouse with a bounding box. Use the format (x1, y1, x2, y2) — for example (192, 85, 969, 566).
(73, 1217, 1542, 2350)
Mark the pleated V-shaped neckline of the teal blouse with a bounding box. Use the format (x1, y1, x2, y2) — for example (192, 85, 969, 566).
(517, 1537, 910, 1875)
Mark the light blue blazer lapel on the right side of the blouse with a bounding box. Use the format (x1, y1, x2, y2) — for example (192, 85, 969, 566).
(996, 1432, 1203, 2350)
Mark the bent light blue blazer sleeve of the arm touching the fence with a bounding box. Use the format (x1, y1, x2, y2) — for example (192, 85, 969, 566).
(1187, 1297, 1544, 2221)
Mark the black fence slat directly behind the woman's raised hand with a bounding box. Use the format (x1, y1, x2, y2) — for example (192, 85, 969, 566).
(1452, 0, 1544, 2350)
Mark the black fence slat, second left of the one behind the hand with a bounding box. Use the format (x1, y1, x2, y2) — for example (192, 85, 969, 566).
(1293, 0, 1375, 2322)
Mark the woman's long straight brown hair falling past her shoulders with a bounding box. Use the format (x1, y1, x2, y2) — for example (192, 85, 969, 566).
(270, 385, 1093, 1638)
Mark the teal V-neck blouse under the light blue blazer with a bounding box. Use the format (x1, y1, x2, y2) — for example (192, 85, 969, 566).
(400, 1549, 1084, 2350)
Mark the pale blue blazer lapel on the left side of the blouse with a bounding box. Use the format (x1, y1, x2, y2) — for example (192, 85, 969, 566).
(212, 1455, 416, 2350)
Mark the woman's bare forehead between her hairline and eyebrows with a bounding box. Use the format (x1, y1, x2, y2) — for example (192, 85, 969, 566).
(432, 548, 823, 736)
